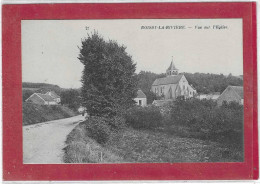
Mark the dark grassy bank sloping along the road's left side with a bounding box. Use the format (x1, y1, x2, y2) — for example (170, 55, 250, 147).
(23, 103, 76, 125)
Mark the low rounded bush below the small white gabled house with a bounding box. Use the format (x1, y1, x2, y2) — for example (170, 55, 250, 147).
(126, 106, 162, 129)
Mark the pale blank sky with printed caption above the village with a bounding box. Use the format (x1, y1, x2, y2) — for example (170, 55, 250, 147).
(22, 19, 243, 88)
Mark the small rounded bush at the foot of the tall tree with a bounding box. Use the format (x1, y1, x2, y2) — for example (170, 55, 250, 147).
(85, 116, 111, 144)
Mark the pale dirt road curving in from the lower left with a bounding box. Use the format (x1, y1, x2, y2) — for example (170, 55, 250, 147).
(23, 115, 84, 164)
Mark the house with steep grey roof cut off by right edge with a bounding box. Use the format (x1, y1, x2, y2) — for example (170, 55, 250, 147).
(217, 86, 244, 106)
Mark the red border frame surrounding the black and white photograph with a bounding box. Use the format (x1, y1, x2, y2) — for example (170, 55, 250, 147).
(2, 2, 259, 180)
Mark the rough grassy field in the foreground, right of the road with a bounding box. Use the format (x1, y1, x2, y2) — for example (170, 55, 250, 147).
(64, 123, 242, 163)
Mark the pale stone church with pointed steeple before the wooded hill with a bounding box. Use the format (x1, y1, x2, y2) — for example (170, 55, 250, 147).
(151, 60, 197, 100)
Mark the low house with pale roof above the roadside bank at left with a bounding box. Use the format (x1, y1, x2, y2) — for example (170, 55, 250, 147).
(25, 93, 58, 105)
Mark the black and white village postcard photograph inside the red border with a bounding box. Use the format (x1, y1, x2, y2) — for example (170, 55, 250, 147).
(21, 19, 244, 164)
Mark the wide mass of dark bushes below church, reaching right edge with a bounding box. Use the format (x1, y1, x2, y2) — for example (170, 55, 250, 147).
(167, 99, 243, 145)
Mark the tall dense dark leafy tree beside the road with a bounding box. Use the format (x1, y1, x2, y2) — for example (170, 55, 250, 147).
(78, 32, 137, 117)
